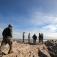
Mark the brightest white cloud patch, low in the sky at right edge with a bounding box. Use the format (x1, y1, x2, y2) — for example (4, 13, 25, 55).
(41, 25, 57, 33)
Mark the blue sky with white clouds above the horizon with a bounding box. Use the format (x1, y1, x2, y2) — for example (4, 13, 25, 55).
(0, 0, 57, 39)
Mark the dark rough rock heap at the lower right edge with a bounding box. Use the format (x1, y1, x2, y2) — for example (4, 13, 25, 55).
(45, 40, 57, 57)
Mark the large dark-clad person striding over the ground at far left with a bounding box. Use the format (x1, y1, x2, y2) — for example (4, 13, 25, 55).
(1, 24, 12, 53)
